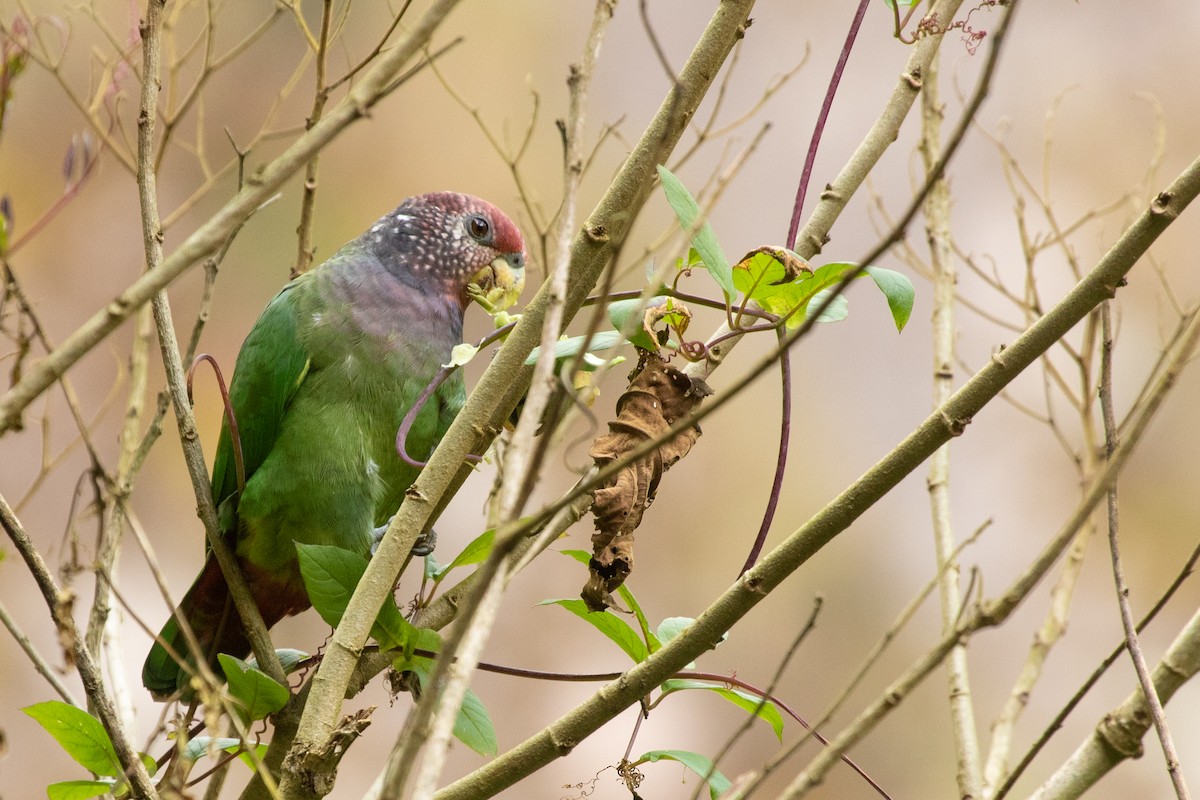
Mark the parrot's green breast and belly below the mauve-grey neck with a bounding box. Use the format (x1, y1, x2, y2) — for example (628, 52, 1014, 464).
(225, 271, 463, 582)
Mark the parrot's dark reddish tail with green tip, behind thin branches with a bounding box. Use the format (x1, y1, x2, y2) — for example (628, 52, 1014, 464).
(142, 555, 308, 700)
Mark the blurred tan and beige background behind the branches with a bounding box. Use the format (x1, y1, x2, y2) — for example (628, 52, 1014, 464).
(0, 0, 1200, 800)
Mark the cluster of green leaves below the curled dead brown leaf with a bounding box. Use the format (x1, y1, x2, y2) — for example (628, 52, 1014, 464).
(541, 551, 784, 800)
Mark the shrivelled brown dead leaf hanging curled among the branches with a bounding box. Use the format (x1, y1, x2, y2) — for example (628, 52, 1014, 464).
(582, 350, 713, 610)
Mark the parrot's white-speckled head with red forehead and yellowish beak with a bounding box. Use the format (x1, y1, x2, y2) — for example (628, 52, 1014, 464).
(365, 192, 524, 307)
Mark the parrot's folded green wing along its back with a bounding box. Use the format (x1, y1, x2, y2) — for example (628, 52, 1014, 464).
(212, 280, 311, 520)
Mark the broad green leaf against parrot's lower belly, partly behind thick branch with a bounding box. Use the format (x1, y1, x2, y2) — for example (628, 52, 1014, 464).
(296, 542, 413, 649)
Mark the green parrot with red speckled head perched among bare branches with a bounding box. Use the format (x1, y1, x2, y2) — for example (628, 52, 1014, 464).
(142, 192, 526, 700)
